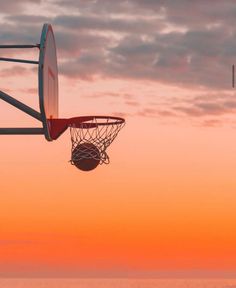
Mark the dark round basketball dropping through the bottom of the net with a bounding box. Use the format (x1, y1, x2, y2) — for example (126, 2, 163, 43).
(72, 143, 100, 171)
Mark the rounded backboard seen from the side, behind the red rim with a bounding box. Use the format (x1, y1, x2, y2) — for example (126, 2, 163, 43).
(38, 24, 58, 141)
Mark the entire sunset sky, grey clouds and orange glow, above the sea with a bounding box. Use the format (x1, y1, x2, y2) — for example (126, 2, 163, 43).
(0, 0, 236, 277)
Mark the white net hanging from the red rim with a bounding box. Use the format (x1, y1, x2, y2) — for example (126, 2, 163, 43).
(69, 116, 125, 165)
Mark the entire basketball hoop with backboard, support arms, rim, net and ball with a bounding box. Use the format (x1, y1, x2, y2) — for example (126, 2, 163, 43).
(0, 23, 125, 171)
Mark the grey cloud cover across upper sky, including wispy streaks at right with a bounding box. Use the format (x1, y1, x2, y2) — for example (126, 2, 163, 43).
(0, 0, 236, 118)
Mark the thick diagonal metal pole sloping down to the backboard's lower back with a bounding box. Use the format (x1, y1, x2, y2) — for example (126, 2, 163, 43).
(0, 91, 42, 122)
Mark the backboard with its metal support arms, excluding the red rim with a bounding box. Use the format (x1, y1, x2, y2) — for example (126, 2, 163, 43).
(0, 23, 58, 141)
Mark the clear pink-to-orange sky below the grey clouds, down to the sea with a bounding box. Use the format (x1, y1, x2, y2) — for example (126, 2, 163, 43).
(0, 1, 236, 276)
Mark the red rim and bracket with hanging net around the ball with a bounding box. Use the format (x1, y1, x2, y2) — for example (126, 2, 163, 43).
(49, 116, 125, 170)
